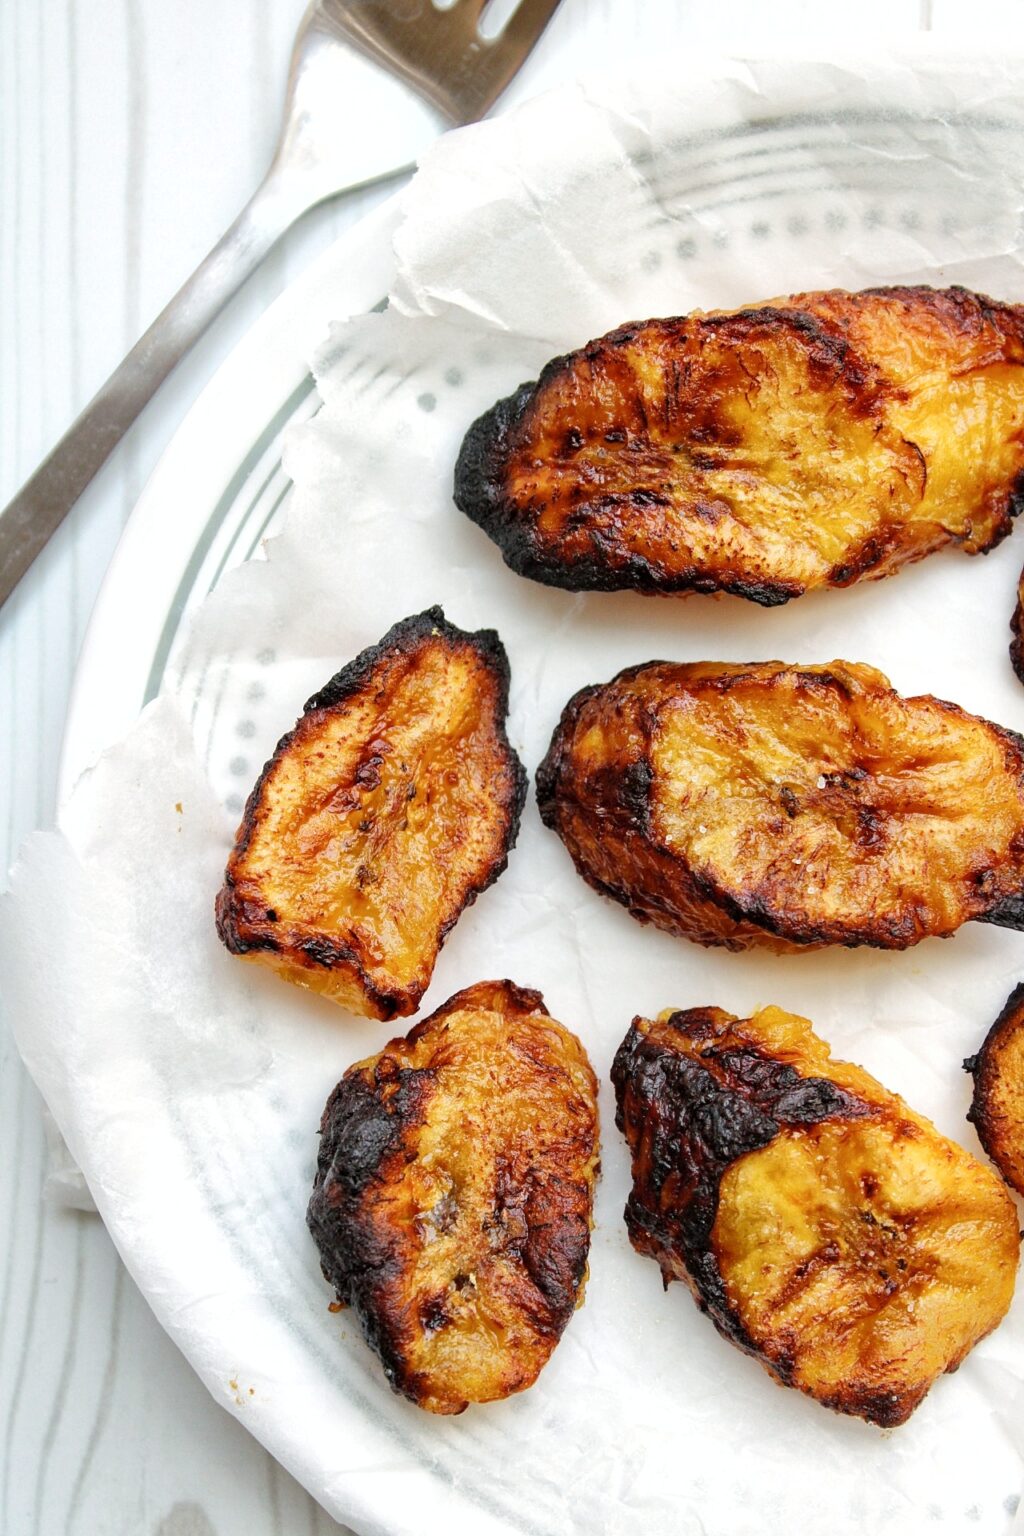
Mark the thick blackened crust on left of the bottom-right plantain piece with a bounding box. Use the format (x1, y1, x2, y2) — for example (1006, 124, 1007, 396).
(611, 1008, 906, 1427)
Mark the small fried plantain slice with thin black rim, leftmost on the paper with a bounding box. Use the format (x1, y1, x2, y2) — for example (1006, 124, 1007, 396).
(216, 608, 527, 1018)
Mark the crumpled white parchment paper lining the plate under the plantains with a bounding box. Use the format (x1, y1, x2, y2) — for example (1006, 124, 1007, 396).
(0, 48, 1024, 1536)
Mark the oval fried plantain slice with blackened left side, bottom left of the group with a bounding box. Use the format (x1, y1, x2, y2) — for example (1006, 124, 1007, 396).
(307, 982, 599, 1413)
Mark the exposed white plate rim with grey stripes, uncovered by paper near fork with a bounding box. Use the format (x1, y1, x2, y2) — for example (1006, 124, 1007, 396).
(58, 194, 401, 800)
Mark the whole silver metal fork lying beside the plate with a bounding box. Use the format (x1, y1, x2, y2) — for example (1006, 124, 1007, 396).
(0, 0, 559, 604)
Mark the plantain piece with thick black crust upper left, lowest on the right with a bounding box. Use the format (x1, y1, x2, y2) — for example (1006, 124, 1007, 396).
(611, 1008, 1019, 1425)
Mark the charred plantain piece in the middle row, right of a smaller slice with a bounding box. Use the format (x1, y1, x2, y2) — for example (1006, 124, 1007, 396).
(537, 662, 1024, 951)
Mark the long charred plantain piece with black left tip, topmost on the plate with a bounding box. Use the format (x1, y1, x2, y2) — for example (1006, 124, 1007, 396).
(454, 287, 1024, 605)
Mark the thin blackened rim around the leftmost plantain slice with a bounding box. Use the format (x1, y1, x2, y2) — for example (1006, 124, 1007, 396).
(215, 604, 528, 1021)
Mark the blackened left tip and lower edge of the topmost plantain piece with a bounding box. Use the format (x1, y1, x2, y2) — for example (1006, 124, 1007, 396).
(453, 371, 806, 608)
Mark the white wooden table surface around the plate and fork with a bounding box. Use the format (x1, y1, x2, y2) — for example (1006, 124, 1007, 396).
(0, 0, 1024, 1536)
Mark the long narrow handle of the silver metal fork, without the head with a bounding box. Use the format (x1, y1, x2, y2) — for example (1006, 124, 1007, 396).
(0, 163, 319, 605)
